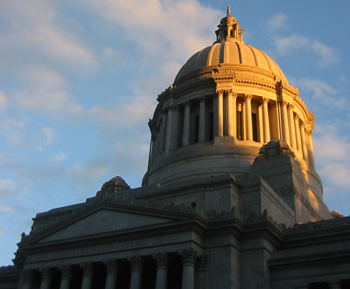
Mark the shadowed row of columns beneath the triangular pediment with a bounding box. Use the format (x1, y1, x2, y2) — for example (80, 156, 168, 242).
(22, 249, 209, 289)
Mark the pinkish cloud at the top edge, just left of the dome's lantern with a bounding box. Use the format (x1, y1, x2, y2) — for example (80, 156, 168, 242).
(84, 0, 222, 60)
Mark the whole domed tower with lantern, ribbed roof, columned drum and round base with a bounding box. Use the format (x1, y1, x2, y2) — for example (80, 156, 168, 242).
(143, 7, 314, 189)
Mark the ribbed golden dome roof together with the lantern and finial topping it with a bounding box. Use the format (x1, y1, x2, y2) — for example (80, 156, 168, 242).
(174, 8, 288, 85)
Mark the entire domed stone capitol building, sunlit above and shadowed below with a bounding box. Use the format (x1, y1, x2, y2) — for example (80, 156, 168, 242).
(0, 8, 350, 289)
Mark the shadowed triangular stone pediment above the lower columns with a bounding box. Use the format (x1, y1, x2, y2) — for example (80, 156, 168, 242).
(37, 208, 189, 243)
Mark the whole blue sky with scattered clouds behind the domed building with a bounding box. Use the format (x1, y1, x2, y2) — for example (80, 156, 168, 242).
(0, 0, 350, 266)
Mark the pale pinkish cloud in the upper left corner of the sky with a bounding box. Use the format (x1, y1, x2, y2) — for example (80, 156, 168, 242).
(0, 0, 97, 69)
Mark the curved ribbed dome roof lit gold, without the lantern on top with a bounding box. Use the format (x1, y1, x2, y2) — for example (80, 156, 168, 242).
(174, 39, 287, 84)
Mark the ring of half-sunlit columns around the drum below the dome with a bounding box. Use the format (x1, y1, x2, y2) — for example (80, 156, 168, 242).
(151, 90, 314, 167)
